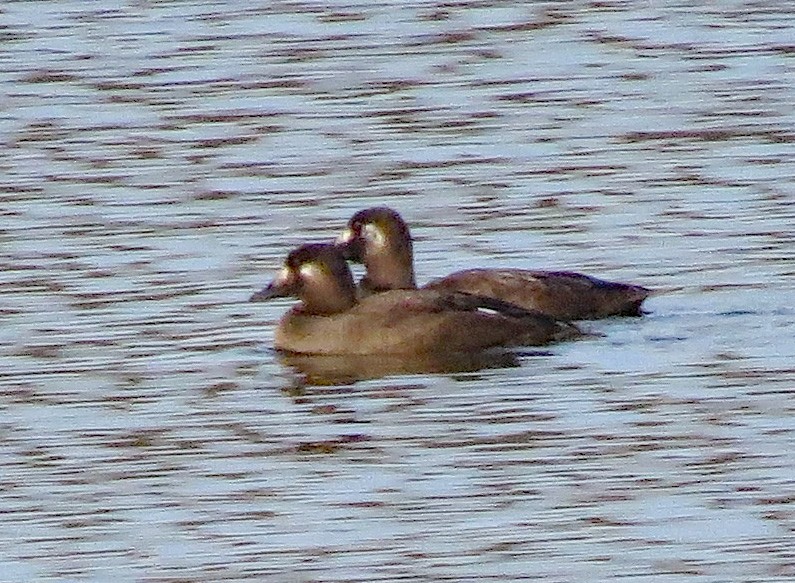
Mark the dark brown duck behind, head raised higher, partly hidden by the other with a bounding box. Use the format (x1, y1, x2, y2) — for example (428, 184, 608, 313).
(337, 207, 653, 321)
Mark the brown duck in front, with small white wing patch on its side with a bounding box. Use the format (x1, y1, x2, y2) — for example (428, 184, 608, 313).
(250, 243, 582, 356)
